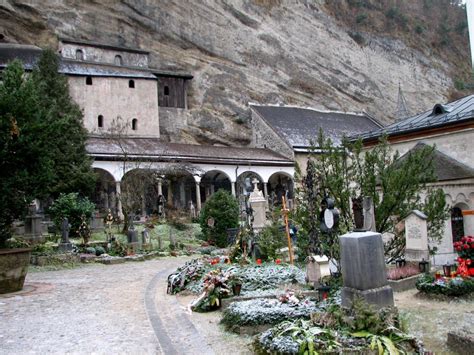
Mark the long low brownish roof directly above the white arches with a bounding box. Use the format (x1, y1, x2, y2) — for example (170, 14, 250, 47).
(87, 137, 294, 166)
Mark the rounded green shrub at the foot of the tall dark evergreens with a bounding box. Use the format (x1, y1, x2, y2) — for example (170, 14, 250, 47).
(48, 192, 95, 238)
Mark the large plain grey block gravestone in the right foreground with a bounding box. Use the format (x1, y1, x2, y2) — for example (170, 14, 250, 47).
(339, 231, 394, 308)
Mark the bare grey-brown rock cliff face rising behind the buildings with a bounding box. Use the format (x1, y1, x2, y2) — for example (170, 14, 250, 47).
(0, 0, 469, 145)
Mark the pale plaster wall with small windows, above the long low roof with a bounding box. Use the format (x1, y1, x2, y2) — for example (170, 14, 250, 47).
(69, 76, 160, 137)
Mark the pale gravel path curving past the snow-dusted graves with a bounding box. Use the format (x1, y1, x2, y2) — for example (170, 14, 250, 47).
(0, 258, 252, 354)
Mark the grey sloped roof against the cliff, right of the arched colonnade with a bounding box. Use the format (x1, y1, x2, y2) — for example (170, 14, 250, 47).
(251, 105, 381, 148)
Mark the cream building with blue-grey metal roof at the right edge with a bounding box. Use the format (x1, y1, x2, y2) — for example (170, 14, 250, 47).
(359, 95, 474, 264)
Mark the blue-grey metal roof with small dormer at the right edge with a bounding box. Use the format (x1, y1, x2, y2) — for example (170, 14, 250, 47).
(352, 95, 474, 140)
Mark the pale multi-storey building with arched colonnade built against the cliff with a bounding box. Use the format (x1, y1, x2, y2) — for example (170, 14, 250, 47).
(0, 39, 294, 217)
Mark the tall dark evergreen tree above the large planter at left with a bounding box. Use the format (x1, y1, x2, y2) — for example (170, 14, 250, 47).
(0, 50, 95, 247)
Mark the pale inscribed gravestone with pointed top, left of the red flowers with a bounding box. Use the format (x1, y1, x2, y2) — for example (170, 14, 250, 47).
(405, 210, 429, 261)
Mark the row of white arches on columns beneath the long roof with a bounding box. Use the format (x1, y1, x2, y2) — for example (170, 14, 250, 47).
(93, 160, 294, 218)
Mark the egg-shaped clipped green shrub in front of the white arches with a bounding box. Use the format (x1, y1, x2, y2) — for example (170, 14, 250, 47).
(199, 189, 239, 247)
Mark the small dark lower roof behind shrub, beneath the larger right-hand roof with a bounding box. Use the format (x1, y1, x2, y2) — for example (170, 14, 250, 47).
(400, 142, 474, 181)
